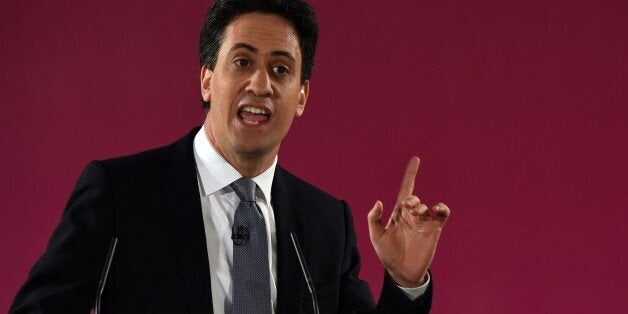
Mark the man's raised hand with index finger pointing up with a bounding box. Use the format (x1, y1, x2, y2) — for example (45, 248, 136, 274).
(368, 157, 450, 287)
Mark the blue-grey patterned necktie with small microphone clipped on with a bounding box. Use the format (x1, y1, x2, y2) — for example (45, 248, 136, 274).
(231, 178, 272, 314)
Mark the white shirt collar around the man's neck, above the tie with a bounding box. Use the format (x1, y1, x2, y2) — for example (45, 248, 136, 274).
(194, 126, 277, 203)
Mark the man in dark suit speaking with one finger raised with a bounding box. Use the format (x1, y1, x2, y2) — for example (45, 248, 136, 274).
(11, 0, 449, 313)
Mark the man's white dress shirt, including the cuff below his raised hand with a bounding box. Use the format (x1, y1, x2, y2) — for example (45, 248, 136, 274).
(194, 127, 430, 314)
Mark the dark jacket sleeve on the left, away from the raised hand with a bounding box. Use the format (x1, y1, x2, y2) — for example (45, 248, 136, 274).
(9, 161, 114, 313)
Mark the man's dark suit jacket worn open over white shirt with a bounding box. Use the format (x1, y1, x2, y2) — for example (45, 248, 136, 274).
(11, 128, 432, 313)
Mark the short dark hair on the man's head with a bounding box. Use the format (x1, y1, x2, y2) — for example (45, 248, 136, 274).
(198, 0, 318, 112)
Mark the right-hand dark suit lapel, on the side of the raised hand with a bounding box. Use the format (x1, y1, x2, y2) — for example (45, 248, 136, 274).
(271, 166, 306, 313)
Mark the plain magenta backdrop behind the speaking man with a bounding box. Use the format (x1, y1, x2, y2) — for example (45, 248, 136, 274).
(0, 0, 628, 313)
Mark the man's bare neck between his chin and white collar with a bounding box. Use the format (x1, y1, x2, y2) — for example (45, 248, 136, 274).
(205, 127, 279, 179)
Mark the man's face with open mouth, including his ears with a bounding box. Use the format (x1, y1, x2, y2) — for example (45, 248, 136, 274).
(201, 13, 309, 161)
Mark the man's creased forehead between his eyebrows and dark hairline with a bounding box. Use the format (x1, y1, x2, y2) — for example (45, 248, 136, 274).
(220, 13, 301, 61)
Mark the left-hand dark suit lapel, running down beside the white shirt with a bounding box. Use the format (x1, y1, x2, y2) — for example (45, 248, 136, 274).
(158, 128, 212, 313)
